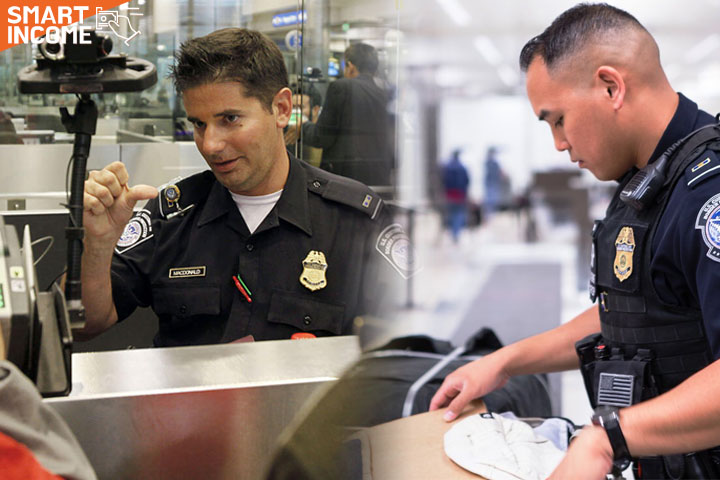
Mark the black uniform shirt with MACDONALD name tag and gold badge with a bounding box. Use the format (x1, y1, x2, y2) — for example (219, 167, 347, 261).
(112, 156, 409, 346)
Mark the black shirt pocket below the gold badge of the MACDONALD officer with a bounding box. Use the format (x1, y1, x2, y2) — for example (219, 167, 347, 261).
(268, 290, 349, 335)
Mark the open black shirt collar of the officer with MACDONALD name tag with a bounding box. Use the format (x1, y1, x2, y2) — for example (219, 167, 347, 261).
(198, 152, 312, 235)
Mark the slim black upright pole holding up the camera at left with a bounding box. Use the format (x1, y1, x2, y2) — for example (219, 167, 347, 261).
(60, 93, 97, 328)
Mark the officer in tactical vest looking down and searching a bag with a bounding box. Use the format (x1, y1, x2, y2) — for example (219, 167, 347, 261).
(431, 4, 720, 479)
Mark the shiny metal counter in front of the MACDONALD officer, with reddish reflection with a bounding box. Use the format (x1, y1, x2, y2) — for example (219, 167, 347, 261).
(45, 337, 360, 480)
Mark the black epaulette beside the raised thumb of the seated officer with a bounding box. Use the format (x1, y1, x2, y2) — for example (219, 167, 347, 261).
(158, 170, 215, 219)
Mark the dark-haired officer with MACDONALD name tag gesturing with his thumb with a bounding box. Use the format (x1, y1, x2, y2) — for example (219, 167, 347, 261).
(82, 29, 412, 346)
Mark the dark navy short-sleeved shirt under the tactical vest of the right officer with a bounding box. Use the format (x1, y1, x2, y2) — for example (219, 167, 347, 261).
(650, 94, 720, 359)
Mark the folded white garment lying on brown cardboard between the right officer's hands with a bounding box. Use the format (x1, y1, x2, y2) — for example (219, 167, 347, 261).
(444, 413, 565, 480)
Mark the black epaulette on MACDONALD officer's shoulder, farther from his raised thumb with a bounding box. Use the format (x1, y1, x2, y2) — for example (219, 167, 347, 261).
(307, 168, 384, 220)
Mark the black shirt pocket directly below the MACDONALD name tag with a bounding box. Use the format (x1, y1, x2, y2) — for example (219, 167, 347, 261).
(152, 286, 220, 319)
